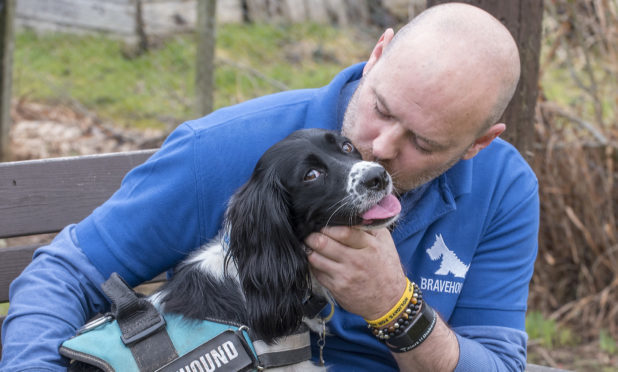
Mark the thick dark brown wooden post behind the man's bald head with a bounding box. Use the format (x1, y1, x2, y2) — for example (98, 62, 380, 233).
(427, 0, 543, 159)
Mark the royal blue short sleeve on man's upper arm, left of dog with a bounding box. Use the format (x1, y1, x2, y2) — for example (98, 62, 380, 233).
(75, 123, 201, 285)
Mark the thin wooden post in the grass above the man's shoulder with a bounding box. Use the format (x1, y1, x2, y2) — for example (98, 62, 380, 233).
(195, 0, 217, 116)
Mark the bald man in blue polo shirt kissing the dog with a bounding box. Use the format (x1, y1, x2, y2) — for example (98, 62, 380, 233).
(0, 3, 539, 371)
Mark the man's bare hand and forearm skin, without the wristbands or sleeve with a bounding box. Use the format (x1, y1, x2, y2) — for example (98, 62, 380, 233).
(306, 227, 459, 371)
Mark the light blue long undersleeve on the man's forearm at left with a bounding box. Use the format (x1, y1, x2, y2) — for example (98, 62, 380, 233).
(0, 225, 107, 371)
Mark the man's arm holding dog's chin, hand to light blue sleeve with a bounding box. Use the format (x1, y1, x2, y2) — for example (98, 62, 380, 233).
(306, 222, 527, 371)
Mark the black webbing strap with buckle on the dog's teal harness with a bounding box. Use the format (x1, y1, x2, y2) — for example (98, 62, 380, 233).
(101, 273, 178, 371)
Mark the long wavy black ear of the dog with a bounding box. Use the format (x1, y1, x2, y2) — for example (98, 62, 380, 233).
(226, 167, 310, 341)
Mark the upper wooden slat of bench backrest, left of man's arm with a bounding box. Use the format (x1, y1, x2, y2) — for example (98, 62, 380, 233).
(0, 150, 155, 238)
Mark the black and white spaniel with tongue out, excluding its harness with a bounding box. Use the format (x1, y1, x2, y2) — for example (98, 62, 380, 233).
(151, 130, 401, 370)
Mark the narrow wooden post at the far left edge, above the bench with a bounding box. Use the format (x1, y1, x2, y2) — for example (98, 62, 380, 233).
(0, 0, 15, 160)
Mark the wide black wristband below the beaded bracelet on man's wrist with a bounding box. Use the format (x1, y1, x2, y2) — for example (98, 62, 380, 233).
(385, 301, 438, 353)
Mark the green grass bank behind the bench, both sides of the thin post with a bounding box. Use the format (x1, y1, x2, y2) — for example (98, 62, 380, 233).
(13, 24, 370, 127)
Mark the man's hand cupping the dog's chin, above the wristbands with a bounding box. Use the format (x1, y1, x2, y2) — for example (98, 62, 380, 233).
(305, 226, 406, 320)
